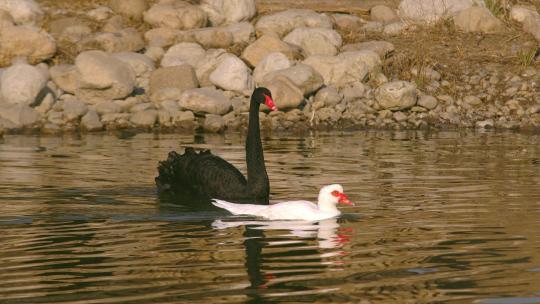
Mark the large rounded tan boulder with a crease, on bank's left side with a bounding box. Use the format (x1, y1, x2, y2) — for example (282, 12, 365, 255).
(75, 51, 136, 103)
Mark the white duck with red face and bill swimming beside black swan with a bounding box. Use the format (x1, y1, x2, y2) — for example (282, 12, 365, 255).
(212, 184, 353, 221)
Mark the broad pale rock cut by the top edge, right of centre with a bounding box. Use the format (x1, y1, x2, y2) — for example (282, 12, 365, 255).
(398, 0, 484, 23)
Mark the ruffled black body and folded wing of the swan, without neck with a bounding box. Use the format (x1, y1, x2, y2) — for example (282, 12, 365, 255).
(155, 148, 247, 201)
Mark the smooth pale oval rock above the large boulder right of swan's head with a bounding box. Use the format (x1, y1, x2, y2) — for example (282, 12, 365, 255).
(283, 27, 342, 56)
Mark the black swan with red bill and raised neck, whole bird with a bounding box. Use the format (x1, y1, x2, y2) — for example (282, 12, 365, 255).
(155, 87, 277, 204)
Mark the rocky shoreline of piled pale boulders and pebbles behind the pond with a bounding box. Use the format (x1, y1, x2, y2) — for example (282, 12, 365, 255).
(0, 0, 540, 134)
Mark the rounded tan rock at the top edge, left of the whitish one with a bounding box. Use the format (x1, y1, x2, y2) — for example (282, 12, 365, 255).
(144, 1, 208, 30)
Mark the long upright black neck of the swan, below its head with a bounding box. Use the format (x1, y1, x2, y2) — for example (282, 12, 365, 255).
(246, 97, 270, 200)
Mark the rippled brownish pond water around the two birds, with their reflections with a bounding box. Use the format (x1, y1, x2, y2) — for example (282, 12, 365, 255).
(0, 131, 540, 304)
